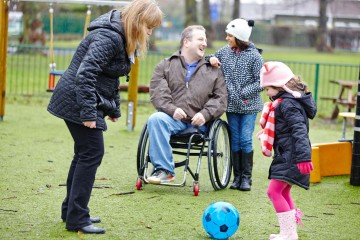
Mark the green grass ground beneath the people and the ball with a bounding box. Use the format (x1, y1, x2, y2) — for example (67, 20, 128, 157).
(0, 98, 360, 240)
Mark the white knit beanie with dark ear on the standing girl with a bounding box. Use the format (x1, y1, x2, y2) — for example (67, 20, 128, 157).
(225, 18, 255, 42)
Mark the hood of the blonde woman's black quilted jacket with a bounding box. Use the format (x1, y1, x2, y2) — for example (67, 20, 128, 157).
(88, 10, 124, 37)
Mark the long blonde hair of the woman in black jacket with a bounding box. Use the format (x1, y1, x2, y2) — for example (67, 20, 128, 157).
(121, 0, 163, 56)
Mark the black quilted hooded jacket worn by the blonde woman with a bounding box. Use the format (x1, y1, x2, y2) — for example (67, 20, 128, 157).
(48, 10, 130, 130)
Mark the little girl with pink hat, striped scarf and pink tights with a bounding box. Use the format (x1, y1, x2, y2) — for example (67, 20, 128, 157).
(258, 62, 316, 240)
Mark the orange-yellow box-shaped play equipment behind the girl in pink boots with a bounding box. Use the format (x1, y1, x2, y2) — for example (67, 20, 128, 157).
(310, 141, 352, 183)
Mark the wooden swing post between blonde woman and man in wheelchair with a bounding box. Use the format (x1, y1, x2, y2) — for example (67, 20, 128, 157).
(126, 57, 139, 131)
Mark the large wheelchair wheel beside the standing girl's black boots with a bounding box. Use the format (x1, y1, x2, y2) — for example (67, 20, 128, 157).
(208, 119, 232, 190)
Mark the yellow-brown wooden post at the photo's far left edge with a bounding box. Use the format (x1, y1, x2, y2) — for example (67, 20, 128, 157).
(0, 0, 9, 121)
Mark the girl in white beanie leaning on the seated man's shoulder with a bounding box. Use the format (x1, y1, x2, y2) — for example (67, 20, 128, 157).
(209, 18, 263, 191)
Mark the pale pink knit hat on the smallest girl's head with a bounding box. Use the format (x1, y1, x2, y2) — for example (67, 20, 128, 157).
(260, 62, 301, 98)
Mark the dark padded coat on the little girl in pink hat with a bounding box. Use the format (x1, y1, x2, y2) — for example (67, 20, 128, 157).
(269, 92, 317, 189)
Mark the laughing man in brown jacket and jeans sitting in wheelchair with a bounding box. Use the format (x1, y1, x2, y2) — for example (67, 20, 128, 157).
(147, 25, 227, 184)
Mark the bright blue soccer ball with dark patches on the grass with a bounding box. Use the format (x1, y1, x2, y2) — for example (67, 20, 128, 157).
(202, 201, 240, 239)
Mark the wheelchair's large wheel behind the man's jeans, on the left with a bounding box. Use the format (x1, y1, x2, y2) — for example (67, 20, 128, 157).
(136, 124, 149, 176)
